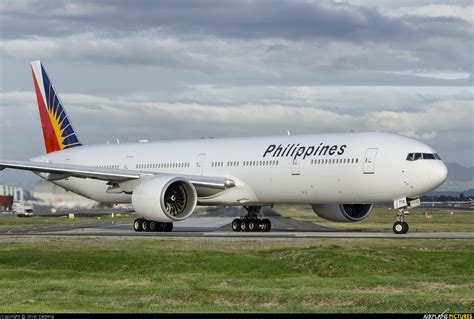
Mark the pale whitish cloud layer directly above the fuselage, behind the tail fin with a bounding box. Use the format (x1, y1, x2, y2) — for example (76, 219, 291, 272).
(0, 90, 474, 165)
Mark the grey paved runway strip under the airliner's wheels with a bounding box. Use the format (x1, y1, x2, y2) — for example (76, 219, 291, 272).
(0, 217, 474, 240)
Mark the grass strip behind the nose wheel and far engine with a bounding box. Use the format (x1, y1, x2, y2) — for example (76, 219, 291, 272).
(274, 205, 474, 232)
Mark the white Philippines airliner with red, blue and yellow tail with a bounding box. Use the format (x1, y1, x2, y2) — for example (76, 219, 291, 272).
(0, 61, 448, 234)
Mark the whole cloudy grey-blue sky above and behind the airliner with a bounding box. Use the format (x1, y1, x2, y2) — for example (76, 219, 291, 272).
(0, 0, 474, 190)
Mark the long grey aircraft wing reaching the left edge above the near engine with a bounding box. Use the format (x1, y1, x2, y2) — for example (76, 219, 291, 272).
(0, 160, 234, 189)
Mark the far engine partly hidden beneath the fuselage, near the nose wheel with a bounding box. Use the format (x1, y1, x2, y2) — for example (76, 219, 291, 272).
(311, 204, 374, 222)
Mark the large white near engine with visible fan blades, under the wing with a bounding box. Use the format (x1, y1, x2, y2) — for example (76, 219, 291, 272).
(132, 176, 197, 222)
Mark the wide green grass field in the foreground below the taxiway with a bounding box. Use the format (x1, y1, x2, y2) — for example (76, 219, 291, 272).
(0, 236, 474, 313)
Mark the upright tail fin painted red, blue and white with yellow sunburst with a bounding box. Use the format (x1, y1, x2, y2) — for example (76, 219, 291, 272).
(31, 61, 81, 153)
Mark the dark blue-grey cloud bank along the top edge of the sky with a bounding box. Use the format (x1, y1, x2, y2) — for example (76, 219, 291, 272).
(0, 0, 403, 39)
